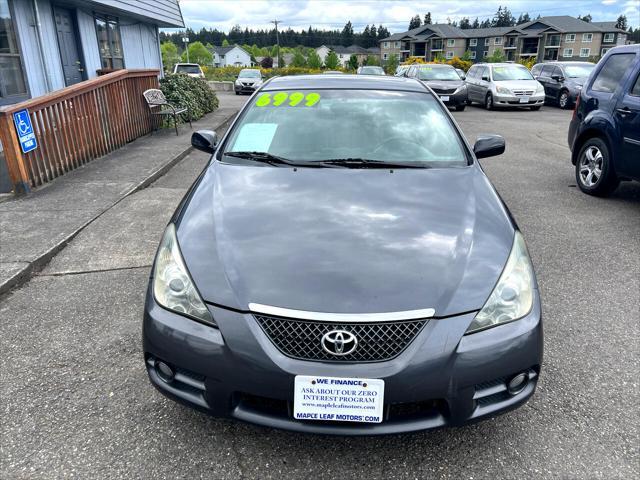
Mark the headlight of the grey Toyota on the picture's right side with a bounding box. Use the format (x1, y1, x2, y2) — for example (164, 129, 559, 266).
(466, 231, 535, 333)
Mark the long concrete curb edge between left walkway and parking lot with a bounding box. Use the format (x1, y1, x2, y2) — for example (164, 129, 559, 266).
(0, 111, 238, 296)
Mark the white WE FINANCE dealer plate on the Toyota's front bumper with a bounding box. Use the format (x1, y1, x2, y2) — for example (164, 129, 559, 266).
(293, 375, 384, 423)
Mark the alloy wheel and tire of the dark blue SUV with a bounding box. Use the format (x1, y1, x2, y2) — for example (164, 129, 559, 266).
(575, 137, 620, 197)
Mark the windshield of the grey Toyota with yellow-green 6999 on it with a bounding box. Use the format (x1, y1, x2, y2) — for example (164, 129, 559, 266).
(222, 89, 468, 168)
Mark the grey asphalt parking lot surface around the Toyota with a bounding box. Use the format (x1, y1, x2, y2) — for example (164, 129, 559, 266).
(0, 95, 640, 479)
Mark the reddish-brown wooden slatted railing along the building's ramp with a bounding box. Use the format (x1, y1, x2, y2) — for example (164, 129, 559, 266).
(0, 70, 159, 194)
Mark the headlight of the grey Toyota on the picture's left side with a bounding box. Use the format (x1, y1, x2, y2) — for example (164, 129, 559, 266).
(153, 223, 215, 325)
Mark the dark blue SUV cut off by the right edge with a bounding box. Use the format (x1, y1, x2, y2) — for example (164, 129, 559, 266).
(569, 45, 640, 196)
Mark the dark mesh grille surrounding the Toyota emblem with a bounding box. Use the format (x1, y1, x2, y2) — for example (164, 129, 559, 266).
(254, 315, 427, 362)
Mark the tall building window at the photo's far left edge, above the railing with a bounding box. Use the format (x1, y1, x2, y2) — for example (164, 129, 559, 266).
(0, 0, 27, 105)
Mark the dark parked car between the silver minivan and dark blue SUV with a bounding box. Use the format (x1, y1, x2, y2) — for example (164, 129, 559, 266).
(531, 62, 596, 108)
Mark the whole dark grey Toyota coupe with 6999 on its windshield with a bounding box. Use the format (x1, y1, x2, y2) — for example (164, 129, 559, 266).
(143, 75, 542, 435)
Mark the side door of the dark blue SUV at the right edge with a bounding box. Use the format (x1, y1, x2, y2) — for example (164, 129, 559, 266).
(615, 68, 640, 181)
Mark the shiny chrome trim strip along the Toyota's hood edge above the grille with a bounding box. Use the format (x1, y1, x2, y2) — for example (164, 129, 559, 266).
(249, 303, 436, 323)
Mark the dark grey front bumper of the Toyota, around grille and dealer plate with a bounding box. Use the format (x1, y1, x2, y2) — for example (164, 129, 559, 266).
(143, 288, 542, 435)
